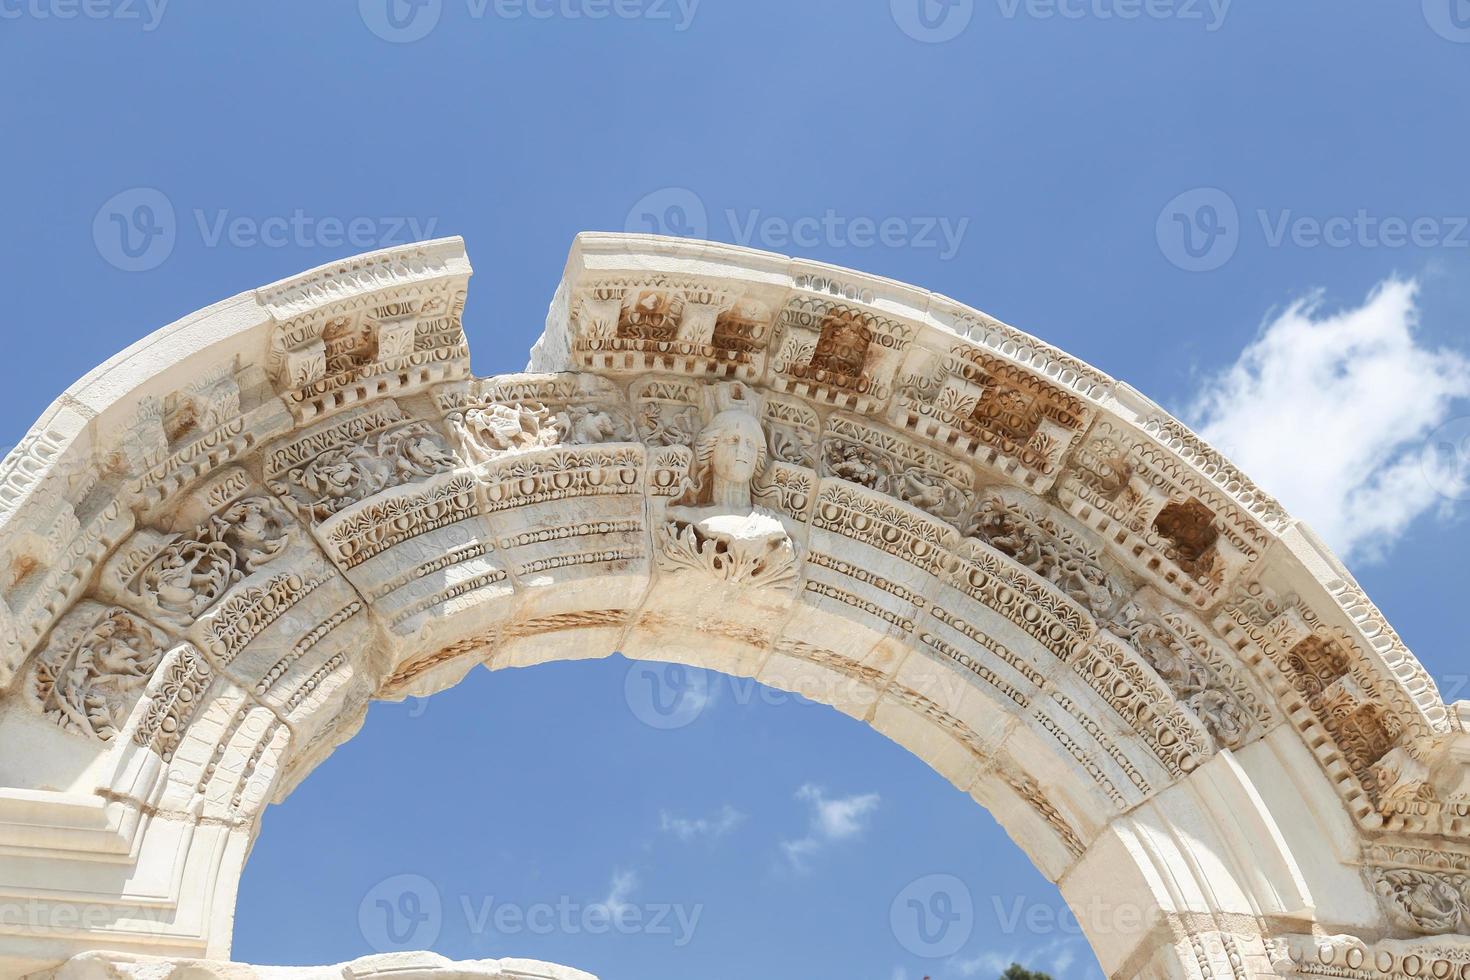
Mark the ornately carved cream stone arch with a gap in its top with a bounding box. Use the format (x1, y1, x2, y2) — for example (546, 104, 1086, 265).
(0, 235, 1470, 980)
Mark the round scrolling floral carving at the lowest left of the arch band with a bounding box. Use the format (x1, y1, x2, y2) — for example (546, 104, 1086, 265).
(34, 607, 162, 741)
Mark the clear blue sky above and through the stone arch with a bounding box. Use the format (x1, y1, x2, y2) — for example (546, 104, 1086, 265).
(0, 0, 1470, 980)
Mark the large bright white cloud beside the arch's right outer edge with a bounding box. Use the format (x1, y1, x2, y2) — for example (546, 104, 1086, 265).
(1188, 279, 1470, 561)
